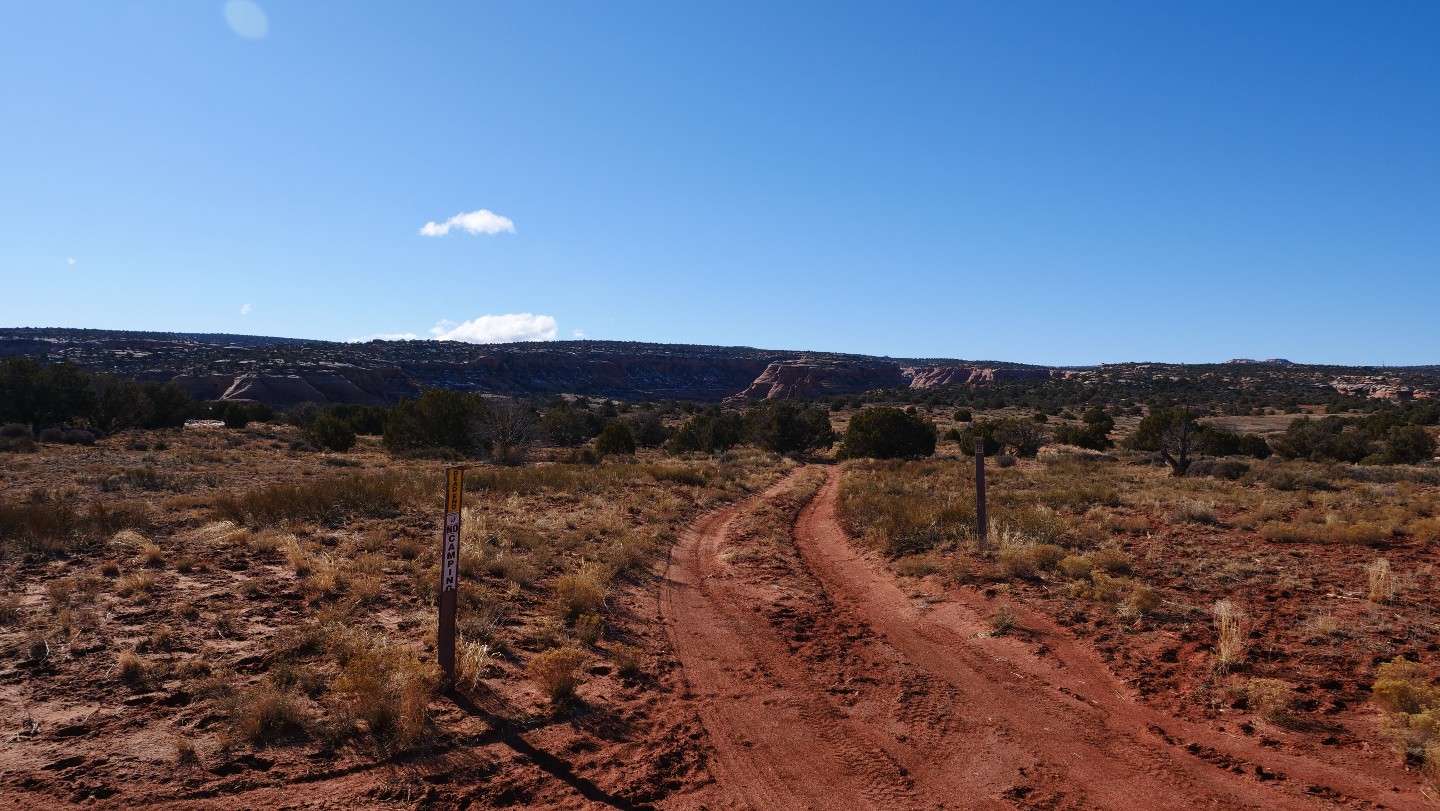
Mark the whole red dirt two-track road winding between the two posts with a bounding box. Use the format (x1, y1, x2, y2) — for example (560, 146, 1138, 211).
(661, 468, 1434, 811)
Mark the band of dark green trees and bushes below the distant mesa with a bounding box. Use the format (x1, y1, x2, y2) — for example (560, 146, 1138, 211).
(0, 352, 1440, 475)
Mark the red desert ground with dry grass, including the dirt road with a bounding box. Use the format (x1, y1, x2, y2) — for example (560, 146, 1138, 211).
(0, 415, 1440, 810)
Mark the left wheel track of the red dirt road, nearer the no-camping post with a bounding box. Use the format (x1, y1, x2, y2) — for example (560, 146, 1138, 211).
(661, 474, 920, 811)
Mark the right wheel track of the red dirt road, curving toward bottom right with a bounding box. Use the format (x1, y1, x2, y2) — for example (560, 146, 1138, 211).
(795, 470, 1428, 808)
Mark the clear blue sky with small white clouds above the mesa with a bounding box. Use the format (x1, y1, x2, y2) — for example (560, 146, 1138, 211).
(0, 0, 1440, 364)
